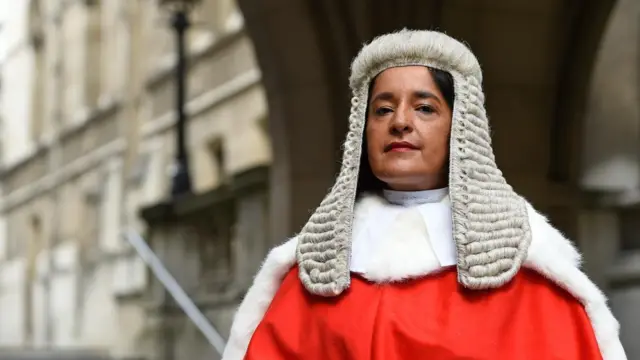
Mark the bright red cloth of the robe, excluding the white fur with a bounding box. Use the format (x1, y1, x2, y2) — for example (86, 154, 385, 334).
(245, 267, 602, 360)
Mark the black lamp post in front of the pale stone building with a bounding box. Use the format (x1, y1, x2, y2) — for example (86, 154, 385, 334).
(158, 0, 200, 197)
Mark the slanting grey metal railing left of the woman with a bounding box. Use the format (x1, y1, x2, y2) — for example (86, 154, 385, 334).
(122, 230, 225, 356)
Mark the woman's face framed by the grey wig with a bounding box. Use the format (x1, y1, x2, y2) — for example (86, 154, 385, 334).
(365, 66, 452, 191)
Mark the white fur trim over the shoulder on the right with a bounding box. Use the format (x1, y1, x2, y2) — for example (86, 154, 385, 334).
(524, 205, 627, 360)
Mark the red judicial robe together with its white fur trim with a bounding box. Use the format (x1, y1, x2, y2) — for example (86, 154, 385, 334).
(222, 199, 626, 360)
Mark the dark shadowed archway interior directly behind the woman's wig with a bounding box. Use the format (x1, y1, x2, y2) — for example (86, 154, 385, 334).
(239, 0, 615, 242)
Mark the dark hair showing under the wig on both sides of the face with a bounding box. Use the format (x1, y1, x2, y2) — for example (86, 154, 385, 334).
(356, 67, 455, 196)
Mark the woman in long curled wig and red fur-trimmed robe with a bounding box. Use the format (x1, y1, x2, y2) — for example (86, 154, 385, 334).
(223, 30, 626, 360)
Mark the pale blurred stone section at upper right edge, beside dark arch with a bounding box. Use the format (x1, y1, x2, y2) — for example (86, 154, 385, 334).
(580, 0, 640, 192)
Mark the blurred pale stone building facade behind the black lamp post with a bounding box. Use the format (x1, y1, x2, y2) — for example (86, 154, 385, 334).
(0, 0, 271, 357)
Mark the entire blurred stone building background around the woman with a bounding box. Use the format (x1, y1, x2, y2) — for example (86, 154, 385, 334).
(0, 0, 640, 360)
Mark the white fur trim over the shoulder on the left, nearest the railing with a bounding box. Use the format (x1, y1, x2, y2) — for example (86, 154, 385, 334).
(222, 238, 297, 360)
